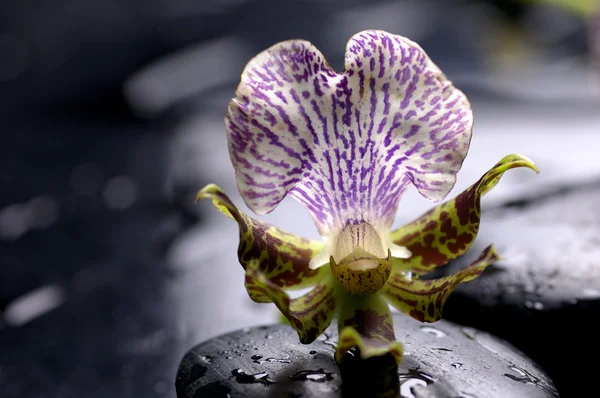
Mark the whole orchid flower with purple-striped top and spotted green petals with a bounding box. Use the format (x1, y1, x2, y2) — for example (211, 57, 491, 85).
(198, 31, 537, 363)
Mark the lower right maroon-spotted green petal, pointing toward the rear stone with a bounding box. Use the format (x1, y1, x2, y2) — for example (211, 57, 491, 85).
(383, 246, 500, 322)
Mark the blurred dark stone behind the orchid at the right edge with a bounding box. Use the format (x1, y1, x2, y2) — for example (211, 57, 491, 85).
(444, 183, 600, 397)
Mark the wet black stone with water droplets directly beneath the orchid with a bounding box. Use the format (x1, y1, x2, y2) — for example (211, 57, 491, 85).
(177, 314, 558, 398)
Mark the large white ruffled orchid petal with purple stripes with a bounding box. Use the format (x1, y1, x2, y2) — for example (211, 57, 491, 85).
(226, 31, 472, 236)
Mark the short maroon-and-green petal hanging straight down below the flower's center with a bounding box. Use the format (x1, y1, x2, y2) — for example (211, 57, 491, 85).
(335, 294, 402, 363)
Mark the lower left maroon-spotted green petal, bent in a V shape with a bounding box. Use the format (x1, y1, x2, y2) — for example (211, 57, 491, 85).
(246, 261, 338, 344)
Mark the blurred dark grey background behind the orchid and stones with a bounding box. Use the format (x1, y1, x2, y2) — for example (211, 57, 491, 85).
(0, 0, 600, 397)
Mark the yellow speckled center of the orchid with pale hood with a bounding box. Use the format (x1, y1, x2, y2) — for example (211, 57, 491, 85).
(329, 223, 392, 296)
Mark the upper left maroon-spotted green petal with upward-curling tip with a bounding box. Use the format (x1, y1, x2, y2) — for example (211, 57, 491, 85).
(197, 184, 326, 289)
